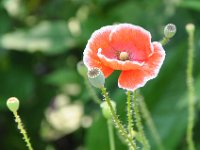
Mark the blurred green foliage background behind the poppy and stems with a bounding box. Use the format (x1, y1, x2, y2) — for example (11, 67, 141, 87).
(0, 0, 200, 150)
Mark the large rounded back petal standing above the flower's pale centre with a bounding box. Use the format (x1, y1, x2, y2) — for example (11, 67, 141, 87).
(108, 24, 153, 61)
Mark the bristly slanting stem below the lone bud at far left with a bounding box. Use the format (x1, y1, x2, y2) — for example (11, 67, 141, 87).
(13, 111, 33, 150)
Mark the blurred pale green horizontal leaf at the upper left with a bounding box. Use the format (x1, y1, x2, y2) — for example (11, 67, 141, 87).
(0, 21, 75, 54)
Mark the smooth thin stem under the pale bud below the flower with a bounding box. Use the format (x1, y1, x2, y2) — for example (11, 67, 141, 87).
(107, 119, 115, 150)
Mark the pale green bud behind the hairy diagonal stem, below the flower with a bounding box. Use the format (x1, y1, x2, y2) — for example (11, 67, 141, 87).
(101, 101, 116, 119)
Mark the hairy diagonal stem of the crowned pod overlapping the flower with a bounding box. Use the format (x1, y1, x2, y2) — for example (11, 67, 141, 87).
(101, 88, 136, 150)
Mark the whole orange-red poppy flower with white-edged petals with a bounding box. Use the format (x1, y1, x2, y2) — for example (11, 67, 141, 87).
(83, 23, 165, 91)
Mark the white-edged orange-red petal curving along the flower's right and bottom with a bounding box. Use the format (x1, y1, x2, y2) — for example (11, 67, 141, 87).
(118, 42, 165, 91)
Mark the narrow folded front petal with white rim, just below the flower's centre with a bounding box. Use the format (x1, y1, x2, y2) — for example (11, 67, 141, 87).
(97, 48, 144, 70)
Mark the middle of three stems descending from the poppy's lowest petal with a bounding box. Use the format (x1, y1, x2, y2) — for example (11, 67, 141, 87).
(133, 91, 150, 150)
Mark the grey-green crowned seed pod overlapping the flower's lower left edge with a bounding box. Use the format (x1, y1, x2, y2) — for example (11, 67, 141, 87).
(88, 67, 105, 88)
